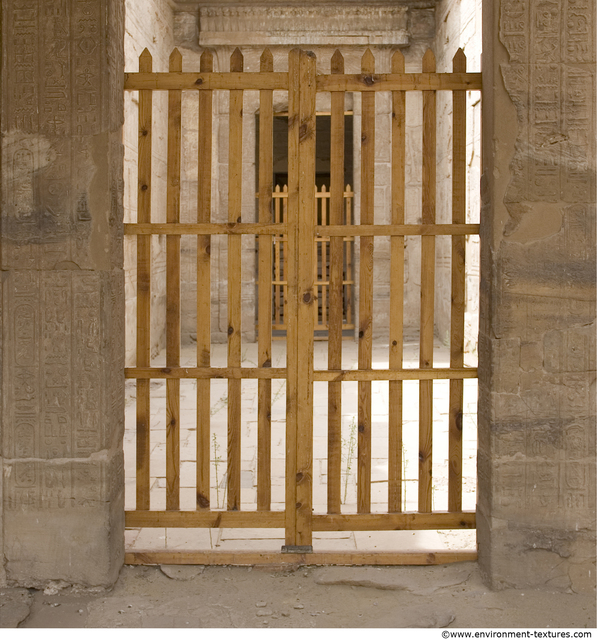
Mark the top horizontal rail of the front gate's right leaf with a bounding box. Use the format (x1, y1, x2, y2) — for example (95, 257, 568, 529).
(317, 73, 483, 92)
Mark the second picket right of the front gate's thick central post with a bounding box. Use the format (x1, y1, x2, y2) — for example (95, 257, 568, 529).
(357, 49, 375, 513)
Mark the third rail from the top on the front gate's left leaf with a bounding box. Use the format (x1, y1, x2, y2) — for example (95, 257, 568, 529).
(124, 367, 286, 380)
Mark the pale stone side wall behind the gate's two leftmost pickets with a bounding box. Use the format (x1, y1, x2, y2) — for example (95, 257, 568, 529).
(124, 0, 174, 366)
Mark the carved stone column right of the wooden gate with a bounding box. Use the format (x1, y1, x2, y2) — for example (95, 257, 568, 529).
(477, 0, 596, 592)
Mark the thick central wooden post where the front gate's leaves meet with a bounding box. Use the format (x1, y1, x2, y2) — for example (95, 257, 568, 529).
(286, 49, 316, 551)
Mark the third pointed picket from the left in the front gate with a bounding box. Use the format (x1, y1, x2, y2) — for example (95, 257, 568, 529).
(196, 51, 213, 509)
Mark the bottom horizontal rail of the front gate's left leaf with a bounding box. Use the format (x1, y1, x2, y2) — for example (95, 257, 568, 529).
(124, 511, 285, 529)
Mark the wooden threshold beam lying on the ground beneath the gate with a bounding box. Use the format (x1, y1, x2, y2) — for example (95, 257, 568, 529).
(124, 550, 477, 567)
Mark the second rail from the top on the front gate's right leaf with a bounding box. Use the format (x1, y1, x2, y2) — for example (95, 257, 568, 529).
(315, 224, 480, 237)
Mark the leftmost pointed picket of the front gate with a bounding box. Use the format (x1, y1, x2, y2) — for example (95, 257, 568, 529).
(136, 49, 153, 510)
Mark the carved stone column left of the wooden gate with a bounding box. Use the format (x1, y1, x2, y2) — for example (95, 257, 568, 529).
(0, 0, 124, 586)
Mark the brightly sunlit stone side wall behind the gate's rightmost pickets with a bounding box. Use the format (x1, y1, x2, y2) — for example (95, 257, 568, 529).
(434, 0, 482, 366)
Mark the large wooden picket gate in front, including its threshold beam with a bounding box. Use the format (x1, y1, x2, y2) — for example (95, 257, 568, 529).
(125, 49, 481, 564)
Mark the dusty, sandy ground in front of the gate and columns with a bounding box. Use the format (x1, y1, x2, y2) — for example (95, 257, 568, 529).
(0, 563, 596, 629)
